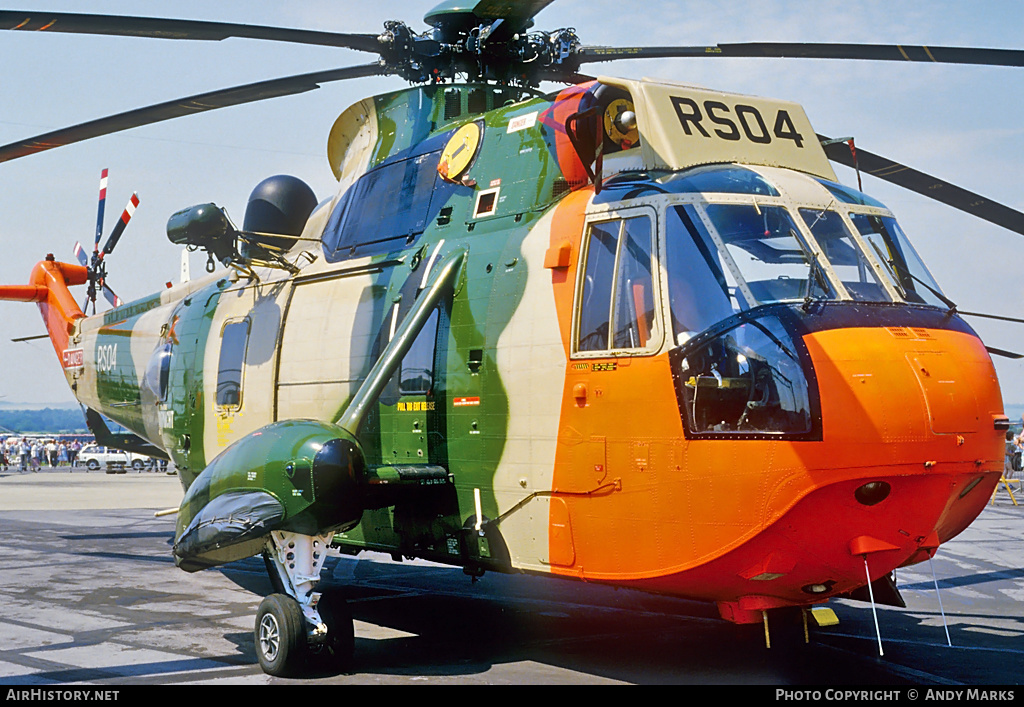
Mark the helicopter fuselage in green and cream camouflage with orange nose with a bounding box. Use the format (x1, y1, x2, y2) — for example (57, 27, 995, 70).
(36, 74, 1002, 621)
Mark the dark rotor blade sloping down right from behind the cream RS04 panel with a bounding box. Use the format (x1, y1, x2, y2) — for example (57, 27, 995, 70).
(818, 135, 1024, 236)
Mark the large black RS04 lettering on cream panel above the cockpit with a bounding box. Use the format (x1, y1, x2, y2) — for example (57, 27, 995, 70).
(672, 95, 804, 148)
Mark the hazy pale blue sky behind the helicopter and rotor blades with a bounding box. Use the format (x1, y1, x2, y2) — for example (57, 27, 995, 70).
(0, 0, 1024, 403)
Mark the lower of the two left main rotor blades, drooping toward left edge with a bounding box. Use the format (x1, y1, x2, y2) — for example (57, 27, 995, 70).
(0, 64, 385, 162)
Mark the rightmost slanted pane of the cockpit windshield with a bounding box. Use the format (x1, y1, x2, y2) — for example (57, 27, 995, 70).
(850, 213, 946, 306)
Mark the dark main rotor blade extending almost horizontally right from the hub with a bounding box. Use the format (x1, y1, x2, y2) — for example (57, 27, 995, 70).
(577, 42, 1024, 67)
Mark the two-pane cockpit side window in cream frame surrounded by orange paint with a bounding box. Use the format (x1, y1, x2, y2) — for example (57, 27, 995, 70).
(577, 211, 656, 351)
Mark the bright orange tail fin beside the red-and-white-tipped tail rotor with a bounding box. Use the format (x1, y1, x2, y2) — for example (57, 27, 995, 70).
(0, 255, 89, 359)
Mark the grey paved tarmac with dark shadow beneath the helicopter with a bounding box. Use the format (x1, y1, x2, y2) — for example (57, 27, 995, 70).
(0, 469, 1024, 684)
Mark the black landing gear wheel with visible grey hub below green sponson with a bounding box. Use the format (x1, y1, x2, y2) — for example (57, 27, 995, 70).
(253, 594, 306, 677)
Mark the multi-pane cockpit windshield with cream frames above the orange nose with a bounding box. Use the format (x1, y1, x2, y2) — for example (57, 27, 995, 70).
(651, 165, 943, 342)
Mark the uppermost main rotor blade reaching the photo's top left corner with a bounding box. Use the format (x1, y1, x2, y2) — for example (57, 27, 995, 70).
(0, 10, 380, 53)
